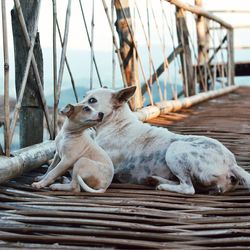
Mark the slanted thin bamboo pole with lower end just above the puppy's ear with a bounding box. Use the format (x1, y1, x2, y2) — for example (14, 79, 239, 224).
(55, 0, 71, 106)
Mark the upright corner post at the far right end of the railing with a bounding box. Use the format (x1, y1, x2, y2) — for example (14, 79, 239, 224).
(227, 29, 235, 86)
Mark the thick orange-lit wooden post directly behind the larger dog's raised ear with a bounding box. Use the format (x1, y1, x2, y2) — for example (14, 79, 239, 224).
(114, 0, 143, 110)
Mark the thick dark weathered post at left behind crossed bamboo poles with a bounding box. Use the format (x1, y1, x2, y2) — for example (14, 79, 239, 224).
(12, 0, 43, 147)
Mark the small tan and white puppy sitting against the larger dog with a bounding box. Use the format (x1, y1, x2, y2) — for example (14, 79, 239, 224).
(32, 103, 114, 193)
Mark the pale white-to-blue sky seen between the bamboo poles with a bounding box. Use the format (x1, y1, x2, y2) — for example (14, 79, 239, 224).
(0, 0, 250, 94)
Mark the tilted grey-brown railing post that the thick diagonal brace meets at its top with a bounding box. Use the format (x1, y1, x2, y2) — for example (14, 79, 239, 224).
(176, 7, 195, 96)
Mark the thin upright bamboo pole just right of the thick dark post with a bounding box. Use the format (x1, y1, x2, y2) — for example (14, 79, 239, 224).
(52, 0, 57, 139)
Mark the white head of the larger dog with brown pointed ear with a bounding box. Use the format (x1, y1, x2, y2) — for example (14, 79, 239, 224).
(82, 86, 136, 121)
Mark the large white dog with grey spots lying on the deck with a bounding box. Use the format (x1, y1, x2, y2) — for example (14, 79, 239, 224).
(83, 87, 250, 194)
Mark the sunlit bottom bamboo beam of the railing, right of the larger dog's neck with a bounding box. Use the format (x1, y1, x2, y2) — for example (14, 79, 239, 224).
(136, 86, 239, 121)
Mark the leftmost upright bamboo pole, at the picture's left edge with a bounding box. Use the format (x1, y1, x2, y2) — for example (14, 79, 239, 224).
(1, 0, 11, 156)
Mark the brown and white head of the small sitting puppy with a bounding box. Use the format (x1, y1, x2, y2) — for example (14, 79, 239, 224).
(60, 103, 103, 127)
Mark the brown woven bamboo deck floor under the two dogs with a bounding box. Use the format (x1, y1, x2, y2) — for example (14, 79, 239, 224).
(0, 87, 250, 249)
